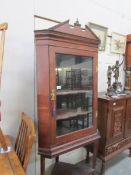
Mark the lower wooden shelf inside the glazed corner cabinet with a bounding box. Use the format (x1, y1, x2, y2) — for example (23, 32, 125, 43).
(56, 110, 92, 120)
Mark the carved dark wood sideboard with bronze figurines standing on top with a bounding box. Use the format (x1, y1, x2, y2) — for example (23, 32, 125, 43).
(98, 94, 131, 174)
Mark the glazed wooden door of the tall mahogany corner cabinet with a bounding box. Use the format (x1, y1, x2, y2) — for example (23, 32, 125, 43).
(50, 48, 96, 144)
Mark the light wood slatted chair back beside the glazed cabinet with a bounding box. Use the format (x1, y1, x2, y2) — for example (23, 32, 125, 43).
(15, 112, 36, 171)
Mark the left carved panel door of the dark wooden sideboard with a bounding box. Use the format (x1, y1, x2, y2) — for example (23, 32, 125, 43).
(107, 100, 126, 144)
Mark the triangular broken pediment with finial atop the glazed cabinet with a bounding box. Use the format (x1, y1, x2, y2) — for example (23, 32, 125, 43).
(49, 20, 99, 42)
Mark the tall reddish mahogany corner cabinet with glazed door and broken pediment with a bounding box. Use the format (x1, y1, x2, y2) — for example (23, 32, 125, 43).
(35, 21, 100, 174)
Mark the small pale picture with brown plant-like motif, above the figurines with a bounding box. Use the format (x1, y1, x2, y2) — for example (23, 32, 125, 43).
(111, 32, 126, 54)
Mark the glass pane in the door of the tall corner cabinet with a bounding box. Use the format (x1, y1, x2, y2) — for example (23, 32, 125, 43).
(56, 53, 93, 136)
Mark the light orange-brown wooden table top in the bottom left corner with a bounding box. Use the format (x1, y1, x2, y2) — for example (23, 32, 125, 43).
(0, 129, 25, 175)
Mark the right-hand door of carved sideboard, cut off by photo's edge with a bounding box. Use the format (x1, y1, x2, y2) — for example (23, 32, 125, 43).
(125, 98, 131, 137)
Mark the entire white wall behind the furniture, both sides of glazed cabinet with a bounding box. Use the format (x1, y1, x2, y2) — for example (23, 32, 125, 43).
(0, 0, 131, 175)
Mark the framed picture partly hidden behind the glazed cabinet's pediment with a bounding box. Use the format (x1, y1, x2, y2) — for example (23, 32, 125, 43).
(88, 22, 108, 51)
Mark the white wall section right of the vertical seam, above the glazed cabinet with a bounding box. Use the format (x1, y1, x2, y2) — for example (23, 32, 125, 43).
(35, 0, 131, 91)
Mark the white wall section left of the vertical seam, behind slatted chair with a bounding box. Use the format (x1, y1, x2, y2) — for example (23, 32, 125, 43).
(0, 0, 35, 175)
